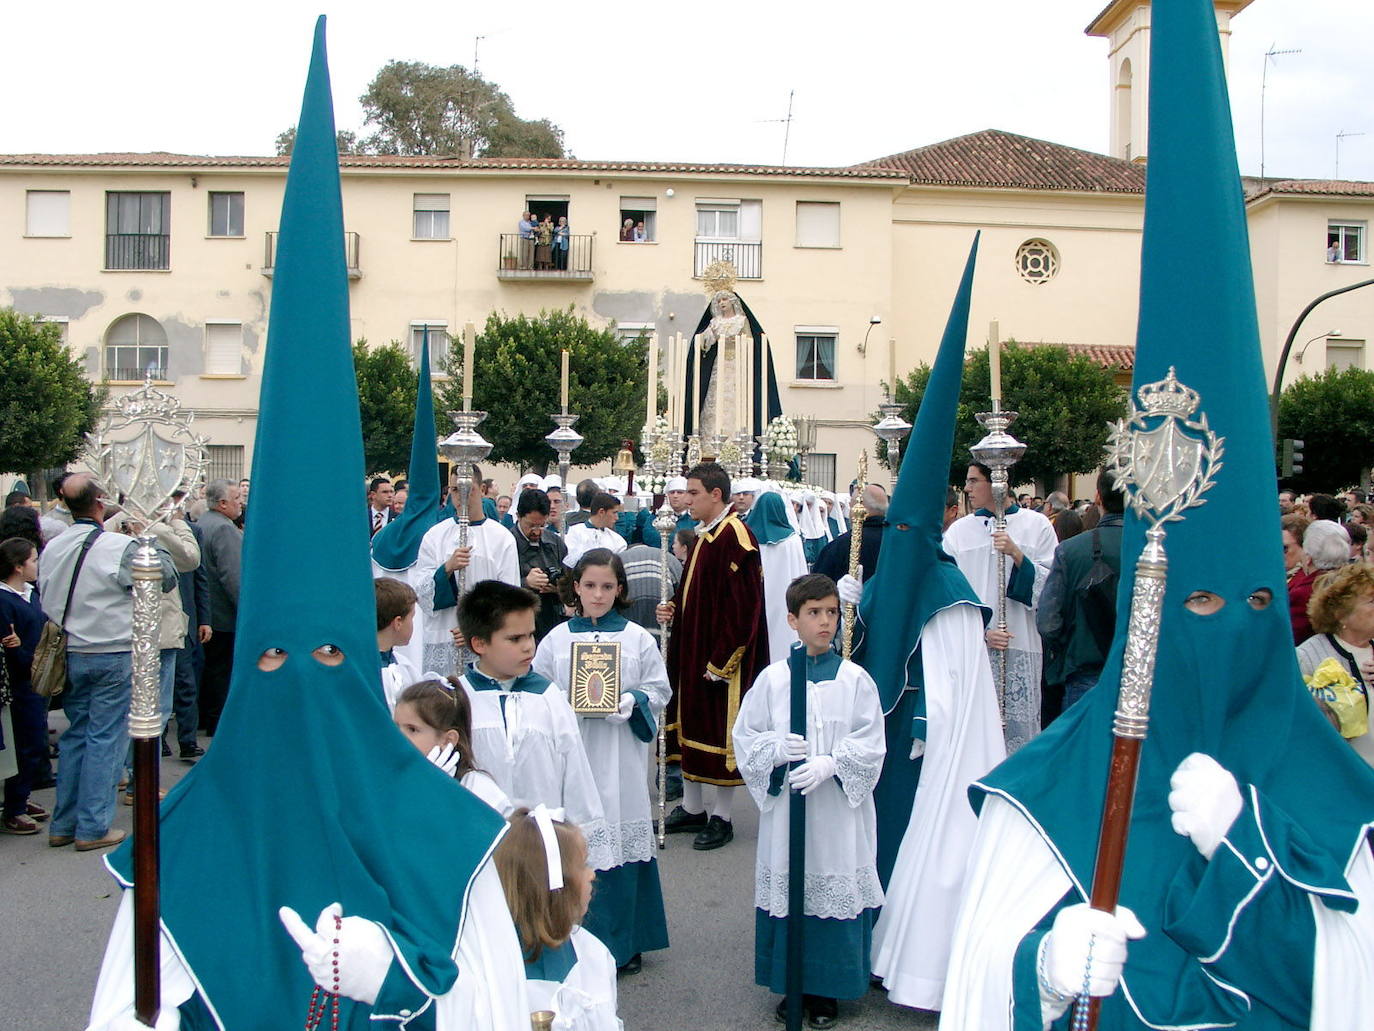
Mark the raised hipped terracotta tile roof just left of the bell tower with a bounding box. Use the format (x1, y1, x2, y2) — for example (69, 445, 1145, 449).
(856, 129, 1145, 194)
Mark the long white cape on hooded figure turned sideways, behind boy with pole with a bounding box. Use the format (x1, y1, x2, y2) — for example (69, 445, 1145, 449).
(872, 605, 1006, 1009)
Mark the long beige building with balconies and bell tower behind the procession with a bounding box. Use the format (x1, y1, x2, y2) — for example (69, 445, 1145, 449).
(0, 0, 1374, 485)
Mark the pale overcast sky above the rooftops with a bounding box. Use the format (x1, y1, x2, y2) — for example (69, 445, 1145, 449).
(0, 0, 1374, 180)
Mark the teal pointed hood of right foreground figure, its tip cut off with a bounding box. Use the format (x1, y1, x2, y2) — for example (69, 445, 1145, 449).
(973, 0, 1374, 1028)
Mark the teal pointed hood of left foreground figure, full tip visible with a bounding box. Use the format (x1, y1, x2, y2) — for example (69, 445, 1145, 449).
(110, 18, 504, 1031)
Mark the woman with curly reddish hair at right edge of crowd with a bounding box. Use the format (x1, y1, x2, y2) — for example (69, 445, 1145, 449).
(1297, 562, 1374, 766)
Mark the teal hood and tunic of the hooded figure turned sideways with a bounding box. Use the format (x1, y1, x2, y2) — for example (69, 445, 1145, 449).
(855, 235, 991, 888)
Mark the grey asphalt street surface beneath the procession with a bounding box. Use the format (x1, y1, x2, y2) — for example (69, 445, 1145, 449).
(0, 731, 934, 1031)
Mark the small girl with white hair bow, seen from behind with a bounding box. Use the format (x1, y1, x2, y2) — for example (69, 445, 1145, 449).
(496, 806, 624, 1031)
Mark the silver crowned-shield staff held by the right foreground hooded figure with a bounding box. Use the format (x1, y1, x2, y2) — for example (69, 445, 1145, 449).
(1073, 366, 1226, 1031)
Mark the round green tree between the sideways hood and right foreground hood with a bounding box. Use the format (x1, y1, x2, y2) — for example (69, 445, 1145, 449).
(878, 341, 1125, 487)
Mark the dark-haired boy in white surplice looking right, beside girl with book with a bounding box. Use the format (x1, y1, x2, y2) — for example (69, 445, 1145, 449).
(458, 580, 616, 870)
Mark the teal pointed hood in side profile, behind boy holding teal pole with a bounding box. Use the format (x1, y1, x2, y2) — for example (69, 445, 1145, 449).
(857, 235, 988, 712)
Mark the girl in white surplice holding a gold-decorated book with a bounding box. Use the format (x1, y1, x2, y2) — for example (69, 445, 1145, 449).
(534, 548, 669, 973)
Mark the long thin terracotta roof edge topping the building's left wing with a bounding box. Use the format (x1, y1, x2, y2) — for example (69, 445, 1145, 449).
(0, 151, 905, 179)
